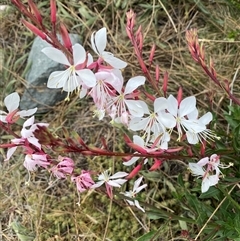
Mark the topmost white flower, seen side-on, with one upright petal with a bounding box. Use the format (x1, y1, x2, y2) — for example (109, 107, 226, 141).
(91, 28, 127, 69)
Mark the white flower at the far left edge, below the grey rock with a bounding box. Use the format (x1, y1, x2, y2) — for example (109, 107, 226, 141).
(0, 92, 37, 123)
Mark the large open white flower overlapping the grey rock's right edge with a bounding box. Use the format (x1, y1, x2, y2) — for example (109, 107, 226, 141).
(42, 43, 96, 98)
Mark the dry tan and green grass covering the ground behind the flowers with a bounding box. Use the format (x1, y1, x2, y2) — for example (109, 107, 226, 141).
(0, 0, 240, 241)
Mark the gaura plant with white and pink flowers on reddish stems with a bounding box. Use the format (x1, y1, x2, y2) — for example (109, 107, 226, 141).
(0, 0, 240, 240)
